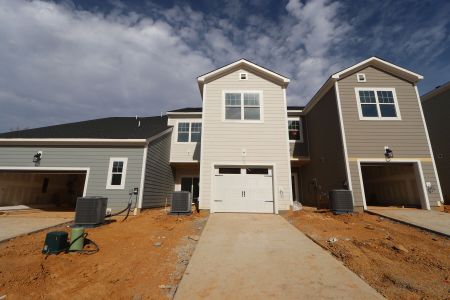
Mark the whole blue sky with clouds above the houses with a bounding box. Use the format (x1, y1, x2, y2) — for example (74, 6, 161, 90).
(0, 0, 450, 132)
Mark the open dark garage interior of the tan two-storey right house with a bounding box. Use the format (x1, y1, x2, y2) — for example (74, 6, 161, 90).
(361, 163, 422, 208)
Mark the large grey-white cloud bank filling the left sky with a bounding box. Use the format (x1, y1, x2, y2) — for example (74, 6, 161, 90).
(0, 1, 213, 130)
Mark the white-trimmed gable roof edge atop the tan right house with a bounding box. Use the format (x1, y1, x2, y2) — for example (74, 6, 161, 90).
(304, 56, 423, 113)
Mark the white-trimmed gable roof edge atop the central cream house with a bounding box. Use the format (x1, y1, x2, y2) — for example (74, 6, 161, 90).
(197, 58, 290, 94)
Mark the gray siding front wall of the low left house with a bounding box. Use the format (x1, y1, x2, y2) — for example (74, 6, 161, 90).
(0, 146, 144, 211)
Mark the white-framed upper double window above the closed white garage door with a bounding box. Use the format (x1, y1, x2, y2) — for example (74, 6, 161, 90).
(225, 92, 261, 121)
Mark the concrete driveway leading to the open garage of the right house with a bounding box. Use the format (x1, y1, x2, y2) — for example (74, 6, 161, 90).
(368, 206, 450, 237)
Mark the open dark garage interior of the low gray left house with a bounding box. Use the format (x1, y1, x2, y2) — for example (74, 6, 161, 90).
(0, 170, 86, 210)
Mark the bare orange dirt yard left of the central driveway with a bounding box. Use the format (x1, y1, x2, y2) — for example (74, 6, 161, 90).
(0, 209, 207, 300)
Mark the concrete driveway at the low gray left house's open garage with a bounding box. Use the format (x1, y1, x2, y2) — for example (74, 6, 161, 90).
(0, 216, 72, 242)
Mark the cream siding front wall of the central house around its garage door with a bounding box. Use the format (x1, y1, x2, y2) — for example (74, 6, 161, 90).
(200, 69, 292, 210)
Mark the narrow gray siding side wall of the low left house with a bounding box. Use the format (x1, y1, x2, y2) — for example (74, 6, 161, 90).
(142, 133, 174, 208)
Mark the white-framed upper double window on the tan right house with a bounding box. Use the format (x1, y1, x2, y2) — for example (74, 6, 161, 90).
(355, 88, 401, 120)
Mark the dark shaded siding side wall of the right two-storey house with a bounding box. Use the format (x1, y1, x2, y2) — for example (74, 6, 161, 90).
(299, 89, 347, 206)
